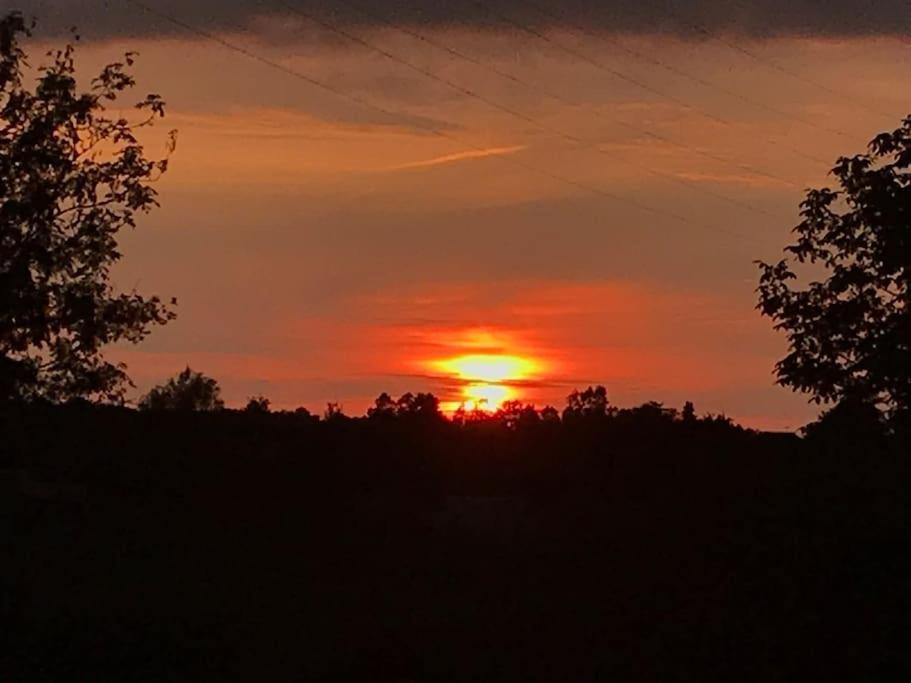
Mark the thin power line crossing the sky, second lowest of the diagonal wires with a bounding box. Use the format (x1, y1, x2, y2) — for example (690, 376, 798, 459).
(279, 0, 792, 218)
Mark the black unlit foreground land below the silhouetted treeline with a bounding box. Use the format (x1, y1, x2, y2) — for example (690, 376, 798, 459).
(0, 407, 911, 682)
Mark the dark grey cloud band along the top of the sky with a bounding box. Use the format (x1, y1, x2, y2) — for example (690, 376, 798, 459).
(14, 0, 911, 39)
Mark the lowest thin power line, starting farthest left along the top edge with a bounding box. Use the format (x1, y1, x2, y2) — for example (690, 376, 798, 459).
(121, 0, 755, 242)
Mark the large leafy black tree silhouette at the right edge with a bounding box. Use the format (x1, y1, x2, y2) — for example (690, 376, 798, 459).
(758, 117, 911, 413)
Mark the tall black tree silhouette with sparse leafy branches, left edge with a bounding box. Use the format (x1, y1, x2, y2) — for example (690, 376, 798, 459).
(0, 12, 176, 402)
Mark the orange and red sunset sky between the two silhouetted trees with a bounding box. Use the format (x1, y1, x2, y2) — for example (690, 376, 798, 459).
(22, 0, 911, 429)
